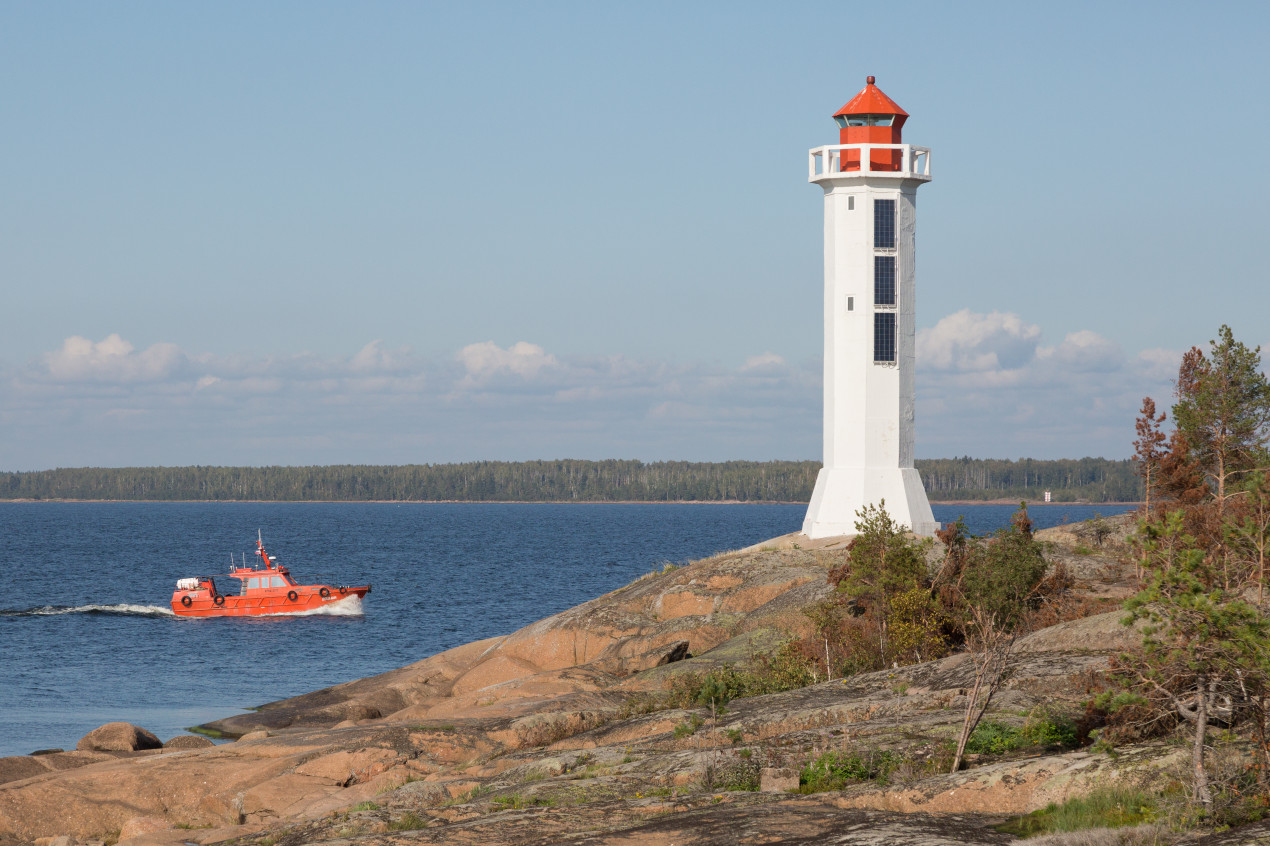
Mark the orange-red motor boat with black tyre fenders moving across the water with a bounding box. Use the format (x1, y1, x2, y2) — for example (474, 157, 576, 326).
(171, 532, 371, 617)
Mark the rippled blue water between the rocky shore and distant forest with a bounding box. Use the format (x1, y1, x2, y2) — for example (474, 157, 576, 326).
(0, 503, 1125, 756)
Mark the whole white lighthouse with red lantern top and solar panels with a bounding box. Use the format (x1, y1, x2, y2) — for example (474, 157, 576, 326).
(803, 76, 939, 537)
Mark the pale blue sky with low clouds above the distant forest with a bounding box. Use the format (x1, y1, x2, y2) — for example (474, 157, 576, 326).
(0, 0, 1270, 471)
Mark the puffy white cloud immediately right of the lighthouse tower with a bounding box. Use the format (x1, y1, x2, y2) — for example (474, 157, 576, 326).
(917, 309, 1040, 371)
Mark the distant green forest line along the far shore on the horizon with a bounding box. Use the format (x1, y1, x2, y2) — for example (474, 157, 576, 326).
(0, 459, 1142, 502)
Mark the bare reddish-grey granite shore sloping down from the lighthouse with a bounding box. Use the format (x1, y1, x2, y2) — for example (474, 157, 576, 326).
(0, 521, 1270, 846)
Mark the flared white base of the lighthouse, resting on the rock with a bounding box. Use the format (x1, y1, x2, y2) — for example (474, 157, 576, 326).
(803, 467, 940, 539)
